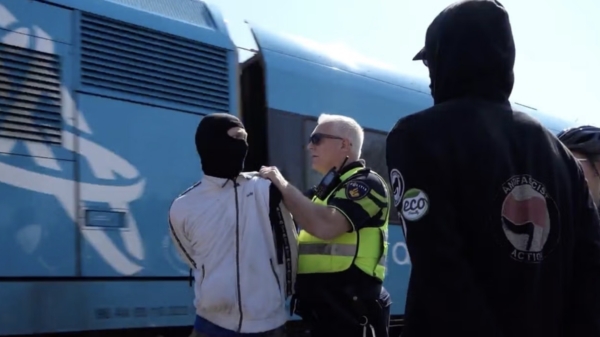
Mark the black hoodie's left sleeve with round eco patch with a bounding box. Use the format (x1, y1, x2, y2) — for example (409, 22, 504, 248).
(386, 115, 501, 337)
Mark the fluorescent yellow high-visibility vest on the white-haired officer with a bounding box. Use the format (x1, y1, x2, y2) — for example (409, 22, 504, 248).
(298, 167, 391, 281)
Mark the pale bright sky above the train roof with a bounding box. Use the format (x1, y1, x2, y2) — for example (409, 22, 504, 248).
(211, 0, 600, 126)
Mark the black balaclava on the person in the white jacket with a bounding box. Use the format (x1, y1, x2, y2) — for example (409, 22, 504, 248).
(196, 113, 248, 179)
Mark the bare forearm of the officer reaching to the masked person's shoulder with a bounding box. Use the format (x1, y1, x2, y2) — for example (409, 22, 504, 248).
(280, 182, 352, 240)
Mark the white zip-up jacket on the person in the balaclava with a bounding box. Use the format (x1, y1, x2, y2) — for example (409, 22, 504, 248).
(169, 172, 297, 333)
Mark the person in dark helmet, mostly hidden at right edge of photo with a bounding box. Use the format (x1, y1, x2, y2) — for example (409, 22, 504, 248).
(558, 125, 600, 207)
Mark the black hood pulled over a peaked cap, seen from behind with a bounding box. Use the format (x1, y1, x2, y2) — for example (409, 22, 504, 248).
(414, 0, 515, 104)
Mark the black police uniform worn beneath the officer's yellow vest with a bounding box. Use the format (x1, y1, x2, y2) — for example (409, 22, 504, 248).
(292, 160, 391, 337)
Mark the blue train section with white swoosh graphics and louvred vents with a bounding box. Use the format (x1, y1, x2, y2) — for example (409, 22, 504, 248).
(0, 0, 238, 335)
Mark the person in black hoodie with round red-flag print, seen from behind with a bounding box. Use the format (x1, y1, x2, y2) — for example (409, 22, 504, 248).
(386, 0, 600, 337)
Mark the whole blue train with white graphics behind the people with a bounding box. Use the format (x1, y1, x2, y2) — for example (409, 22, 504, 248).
(0, 0, 567, 336)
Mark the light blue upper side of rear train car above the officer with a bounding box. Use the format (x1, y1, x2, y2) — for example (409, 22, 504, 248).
(253, 28, 433, 132)
